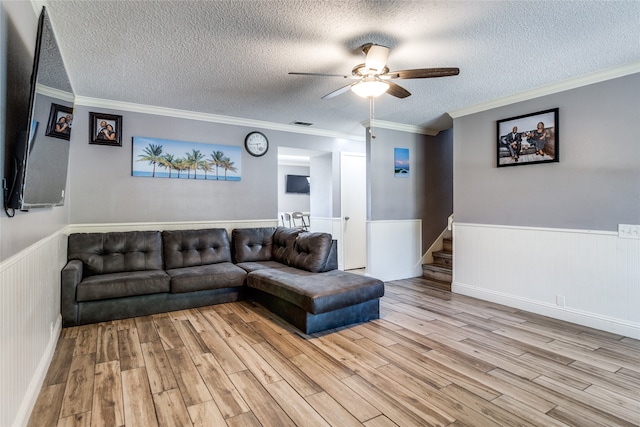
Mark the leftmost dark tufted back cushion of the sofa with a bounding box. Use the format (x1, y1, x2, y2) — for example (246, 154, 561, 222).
(67, 231, 162, 276)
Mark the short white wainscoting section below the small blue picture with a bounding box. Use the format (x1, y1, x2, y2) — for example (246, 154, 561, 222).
(367, 220, 422, 281)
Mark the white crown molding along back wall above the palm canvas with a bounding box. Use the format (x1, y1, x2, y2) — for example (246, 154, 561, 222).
(76, 95, 365, 141)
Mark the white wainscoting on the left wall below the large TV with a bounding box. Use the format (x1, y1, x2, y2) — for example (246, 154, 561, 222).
(0, 230, 67, 426)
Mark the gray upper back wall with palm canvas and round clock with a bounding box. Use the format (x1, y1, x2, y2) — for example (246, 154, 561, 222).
(69, 106, 364, 224)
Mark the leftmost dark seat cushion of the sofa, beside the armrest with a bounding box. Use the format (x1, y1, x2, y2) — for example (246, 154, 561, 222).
(76, 270, 170, 302)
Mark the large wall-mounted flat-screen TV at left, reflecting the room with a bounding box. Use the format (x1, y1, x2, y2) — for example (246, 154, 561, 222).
(5, 7, 75, 211)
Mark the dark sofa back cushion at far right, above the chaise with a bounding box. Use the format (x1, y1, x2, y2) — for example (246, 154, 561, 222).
(289, 232, 332, 273)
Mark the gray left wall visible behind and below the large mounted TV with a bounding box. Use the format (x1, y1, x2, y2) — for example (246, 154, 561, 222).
(0, 1, 69, 261)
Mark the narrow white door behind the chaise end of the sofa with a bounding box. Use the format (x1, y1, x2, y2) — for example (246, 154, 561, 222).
(340, 154, 367, 270)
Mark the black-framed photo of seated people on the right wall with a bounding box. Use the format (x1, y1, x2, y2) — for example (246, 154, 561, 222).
(496, 108, 560, 167)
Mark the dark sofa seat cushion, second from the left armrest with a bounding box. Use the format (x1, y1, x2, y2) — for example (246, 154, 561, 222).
(167, 262, 247, 294)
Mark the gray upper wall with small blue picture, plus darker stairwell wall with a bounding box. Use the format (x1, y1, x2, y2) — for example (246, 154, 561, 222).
(367, 128, 453, 254)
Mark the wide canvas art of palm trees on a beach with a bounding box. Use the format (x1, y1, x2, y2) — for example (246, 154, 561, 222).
(131, 136, 242, 181)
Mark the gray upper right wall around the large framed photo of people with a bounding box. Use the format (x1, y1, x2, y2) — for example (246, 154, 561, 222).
(454, 74, 640, 231)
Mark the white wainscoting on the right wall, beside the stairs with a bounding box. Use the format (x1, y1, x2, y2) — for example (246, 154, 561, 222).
(452, 223, 640, 339)
